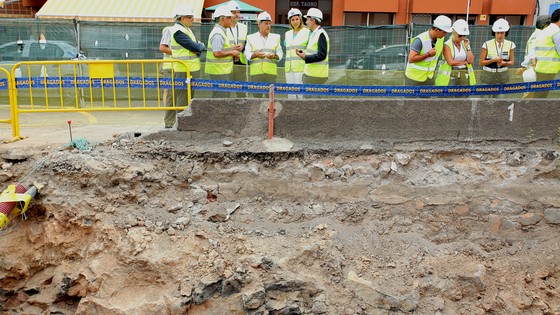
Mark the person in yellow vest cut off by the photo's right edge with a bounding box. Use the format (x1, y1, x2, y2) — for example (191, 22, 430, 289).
(534, 9, 560, 98)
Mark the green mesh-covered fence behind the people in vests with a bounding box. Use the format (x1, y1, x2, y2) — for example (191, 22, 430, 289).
(0, 19, 552, 97)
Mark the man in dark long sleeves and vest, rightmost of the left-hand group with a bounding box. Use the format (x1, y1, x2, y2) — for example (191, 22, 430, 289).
(296, 8, 331, 84)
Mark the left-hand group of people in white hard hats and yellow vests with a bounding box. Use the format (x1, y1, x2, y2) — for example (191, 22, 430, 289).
(160, 0, 330, 128)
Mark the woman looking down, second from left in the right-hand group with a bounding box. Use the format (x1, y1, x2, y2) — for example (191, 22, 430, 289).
(436, 19, 476, 86)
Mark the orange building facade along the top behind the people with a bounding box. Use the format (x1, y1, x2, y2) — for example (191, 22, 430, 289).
(204, 0, 537, 26)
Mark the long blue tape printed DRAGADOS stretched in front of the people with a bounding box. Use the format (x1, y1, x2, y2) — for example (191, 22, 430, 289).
(7, 77, 560, 97)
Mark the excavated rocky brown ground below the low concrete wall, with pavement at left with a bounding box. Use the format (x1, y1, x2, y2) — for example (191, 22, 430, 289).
(0, 111, 560, 315)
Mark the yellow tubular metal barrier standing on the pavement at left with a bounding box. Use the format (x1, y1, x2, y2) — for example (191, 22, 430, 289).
(7, 59, 191, 140)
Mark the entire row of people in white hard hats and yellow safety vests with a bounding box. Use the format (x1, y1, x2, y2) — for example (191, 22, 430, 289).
(155, 0, 560, 128)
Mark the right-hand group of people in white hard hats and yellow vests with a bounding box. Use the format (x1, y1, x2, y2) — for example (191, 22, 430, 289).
(405, 9, 560, 98)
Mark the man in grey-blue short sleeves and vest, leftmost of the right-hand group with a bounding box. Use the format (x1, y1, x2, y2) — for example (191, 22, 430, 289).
(404, 15, 452, 85)
